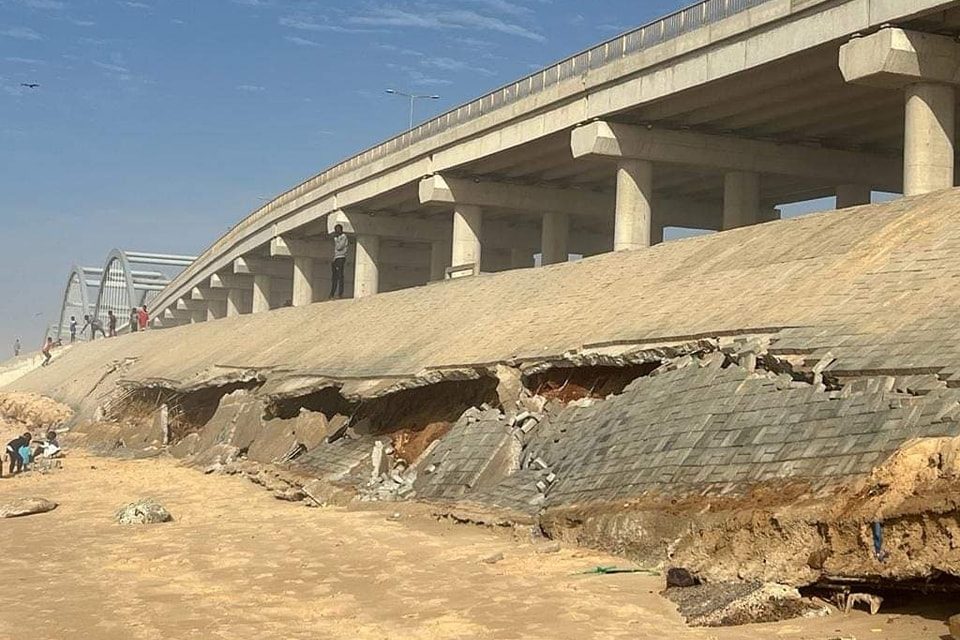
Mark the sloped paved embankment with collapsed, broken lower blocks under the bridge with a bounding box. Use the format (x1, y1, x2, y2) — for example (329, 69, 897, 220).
(5, 191, 960, 588)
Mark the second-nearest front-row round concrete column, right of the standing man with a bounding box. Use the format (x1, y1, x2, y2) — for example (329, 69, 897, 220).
(613, 159, 653, 251)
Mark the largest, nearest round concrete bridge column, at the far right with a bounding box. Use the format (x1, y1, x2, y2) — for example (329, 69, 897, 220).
(903, 82, 956, 196)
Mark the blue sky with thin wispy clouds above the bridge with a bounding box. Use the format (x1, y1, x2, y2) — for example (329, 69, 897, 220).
(0, 0, 864, 356)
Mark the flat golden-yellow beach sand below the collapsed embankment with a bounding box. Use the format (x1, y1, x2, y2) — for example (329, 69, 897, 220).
(0, 422, 947, 640)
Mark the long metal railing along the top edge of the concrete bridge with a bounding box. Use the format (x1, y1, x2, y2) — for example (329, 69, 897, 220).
(169, 0, 772, 296)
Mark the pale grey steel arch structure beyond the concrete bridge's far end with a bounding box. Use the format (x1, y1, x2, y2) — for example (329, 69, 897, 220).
(54, 249, 195, 340)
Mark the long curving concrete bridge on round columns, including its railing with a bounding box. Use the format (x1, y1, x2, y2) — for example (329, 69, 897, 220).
(151, 0, 960, 326)
